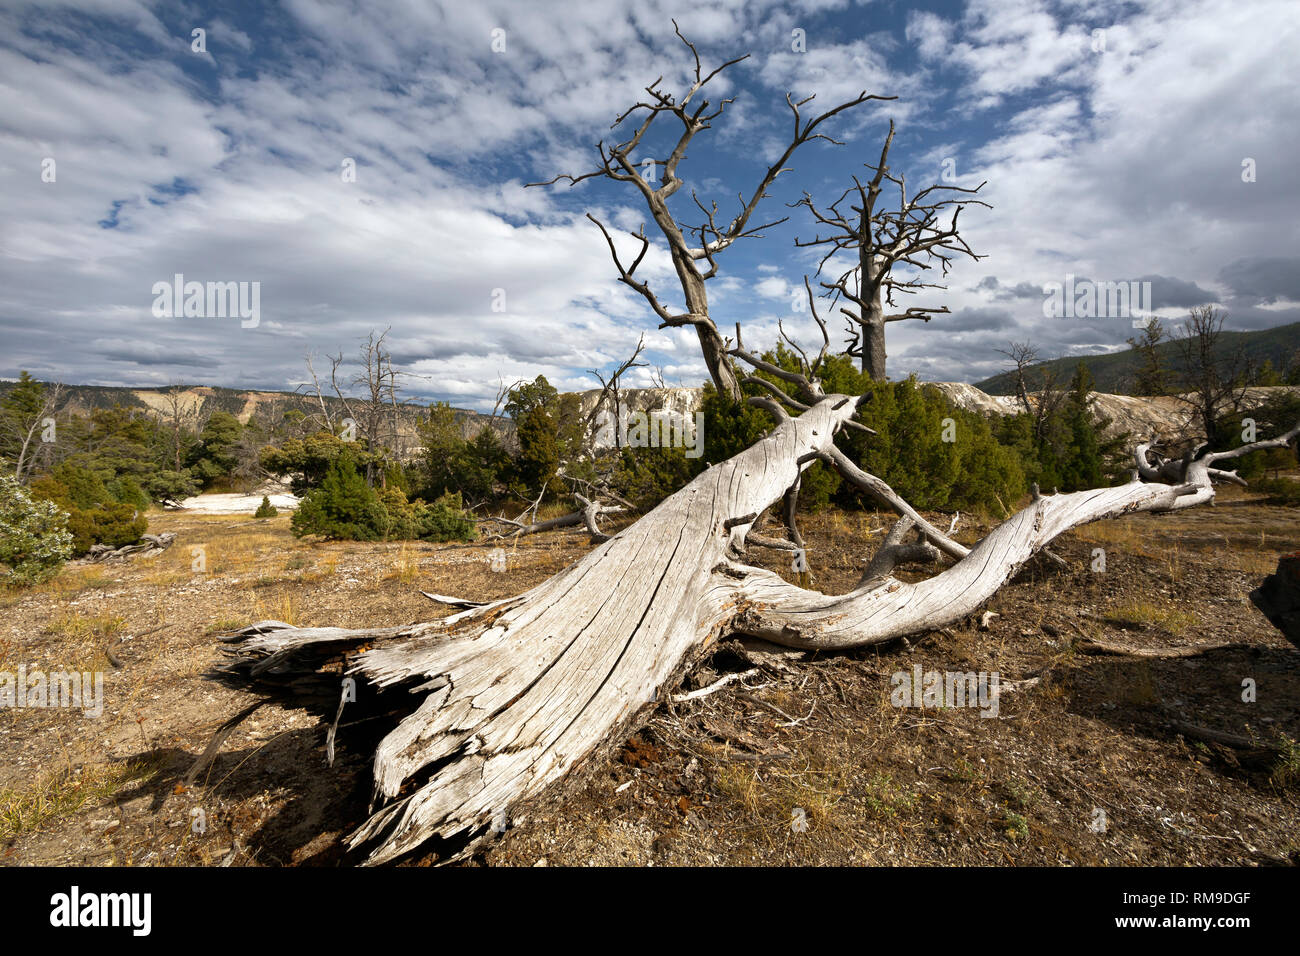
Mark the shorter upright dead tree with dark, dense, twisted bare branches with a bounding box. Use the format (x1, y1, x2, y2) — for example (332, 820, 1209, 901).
(794, 120, 988, 380)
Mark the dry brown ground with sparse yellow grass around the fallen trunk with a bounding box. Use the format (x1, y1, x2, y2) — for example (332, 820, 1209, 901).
(0, 489, 1300, 866)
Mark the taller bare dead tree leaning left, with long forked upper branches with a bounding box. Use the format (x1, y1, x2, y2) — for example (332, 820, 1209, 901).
(529, 21, 896, 401)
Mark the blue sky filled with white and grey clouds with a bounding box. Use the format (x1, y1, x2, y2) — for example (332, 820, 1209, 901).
(0, 0, 1300, 408)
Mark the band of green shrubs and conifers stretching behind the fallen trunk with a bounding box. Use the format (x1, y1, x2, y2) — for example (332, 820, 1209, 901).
(0, 316, 1300, 567)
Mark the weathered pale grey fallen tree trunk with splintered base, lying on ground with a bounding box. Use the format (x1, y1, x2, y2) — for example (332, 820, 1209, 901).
(208, 31, 1300, 862)
